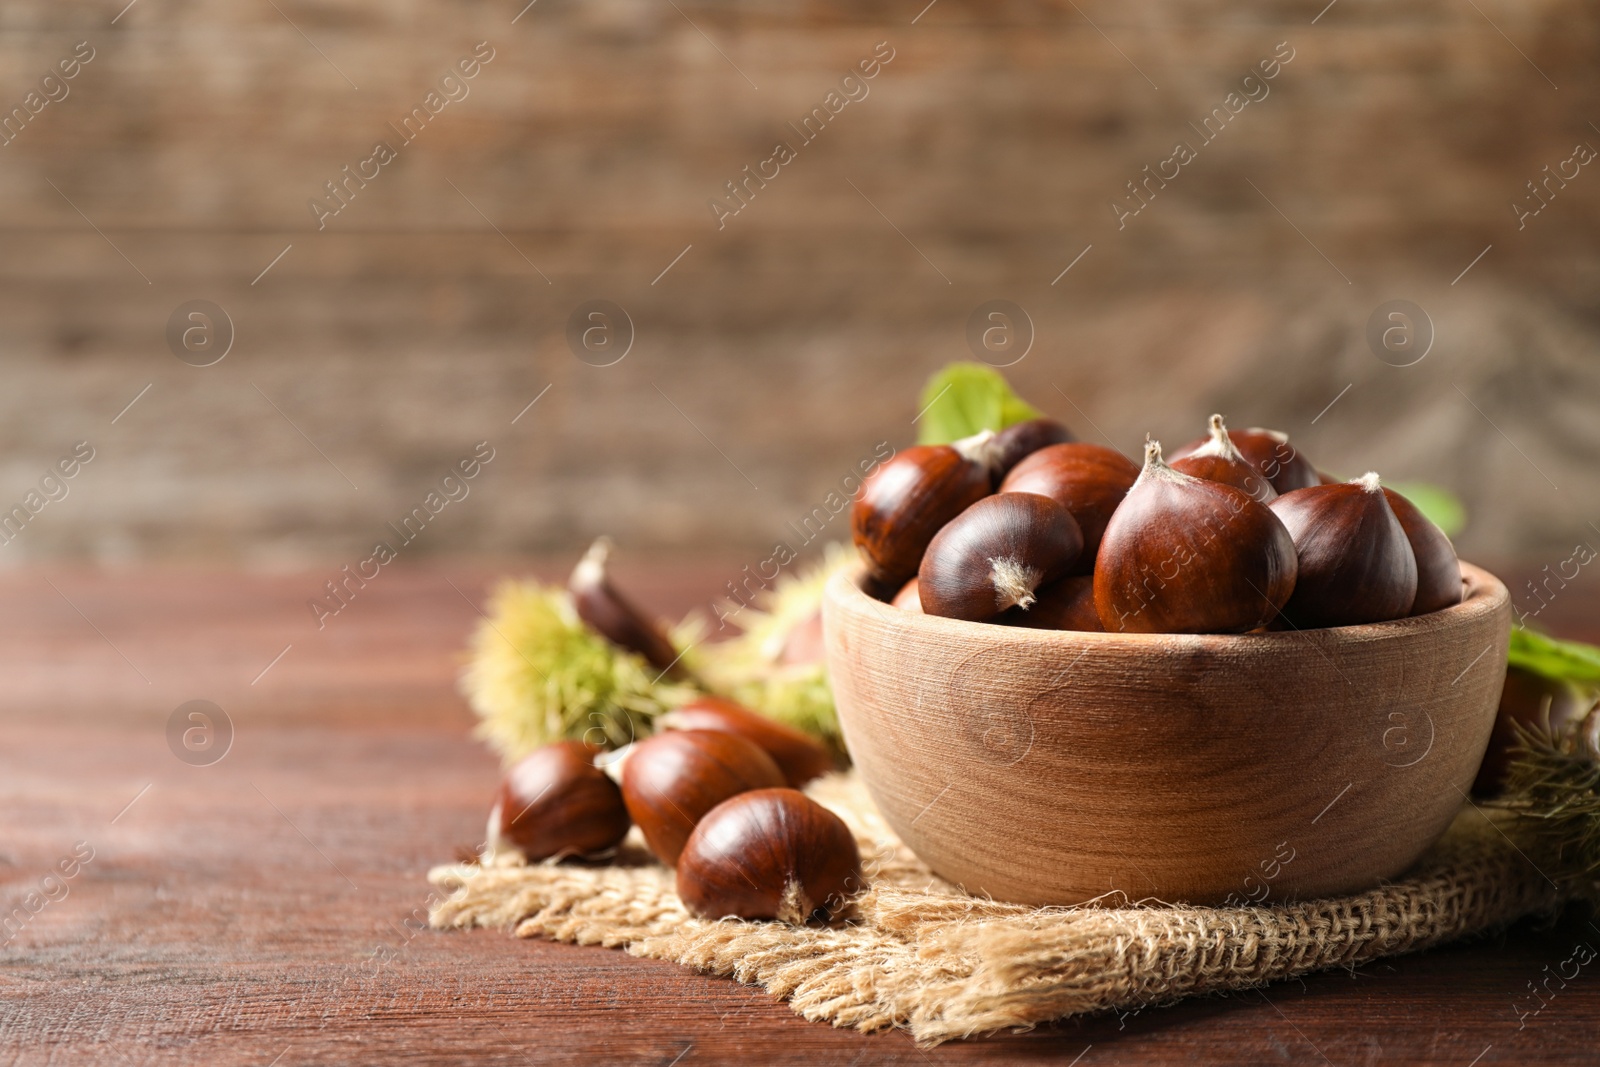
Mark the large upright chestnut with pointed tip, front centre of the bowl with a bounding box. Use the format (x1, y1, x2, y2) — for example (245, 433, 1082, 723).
(1094, 442, 1296, 633)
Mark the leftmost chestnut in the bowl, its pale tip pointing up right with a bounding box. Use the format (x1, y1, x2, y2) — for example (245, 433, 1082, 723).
(850, 430, 994, 590)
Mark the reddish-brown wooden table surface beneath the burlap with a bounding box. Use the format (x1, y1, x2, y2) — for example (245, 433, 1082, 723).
(0, 560, 1600, 1067)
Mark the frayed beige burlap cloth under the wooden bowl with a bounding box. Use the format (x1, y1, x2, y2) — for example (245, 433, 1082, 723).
(429, 774, 1578, 1043)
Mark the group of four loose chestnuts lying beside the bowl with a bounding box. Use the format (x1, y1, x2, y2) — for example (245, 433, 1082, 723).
(490, 696, 864, 925)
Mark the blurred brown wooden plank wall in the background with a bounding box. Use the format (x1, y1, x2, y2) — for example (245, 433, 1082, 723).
(0, 0, 1600, 566)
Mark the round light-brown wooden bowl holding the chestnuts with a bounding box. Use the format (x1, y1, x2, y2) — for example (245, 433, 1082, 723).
(822, 563, 1510, 904)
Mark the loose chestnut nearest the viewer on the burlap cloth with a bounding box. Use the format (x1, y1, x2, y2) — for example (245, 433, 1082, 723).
(678, 789, 866, 925)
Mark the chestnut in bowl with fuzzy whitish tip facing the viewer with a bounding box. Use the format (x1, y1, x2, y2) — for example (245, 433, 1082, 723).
(917, 493, 1083, 622)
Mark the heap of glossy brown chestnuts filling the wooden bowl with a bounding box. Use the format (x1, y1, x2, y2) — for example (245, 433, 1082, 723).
(851, 414, 1462, 633)
